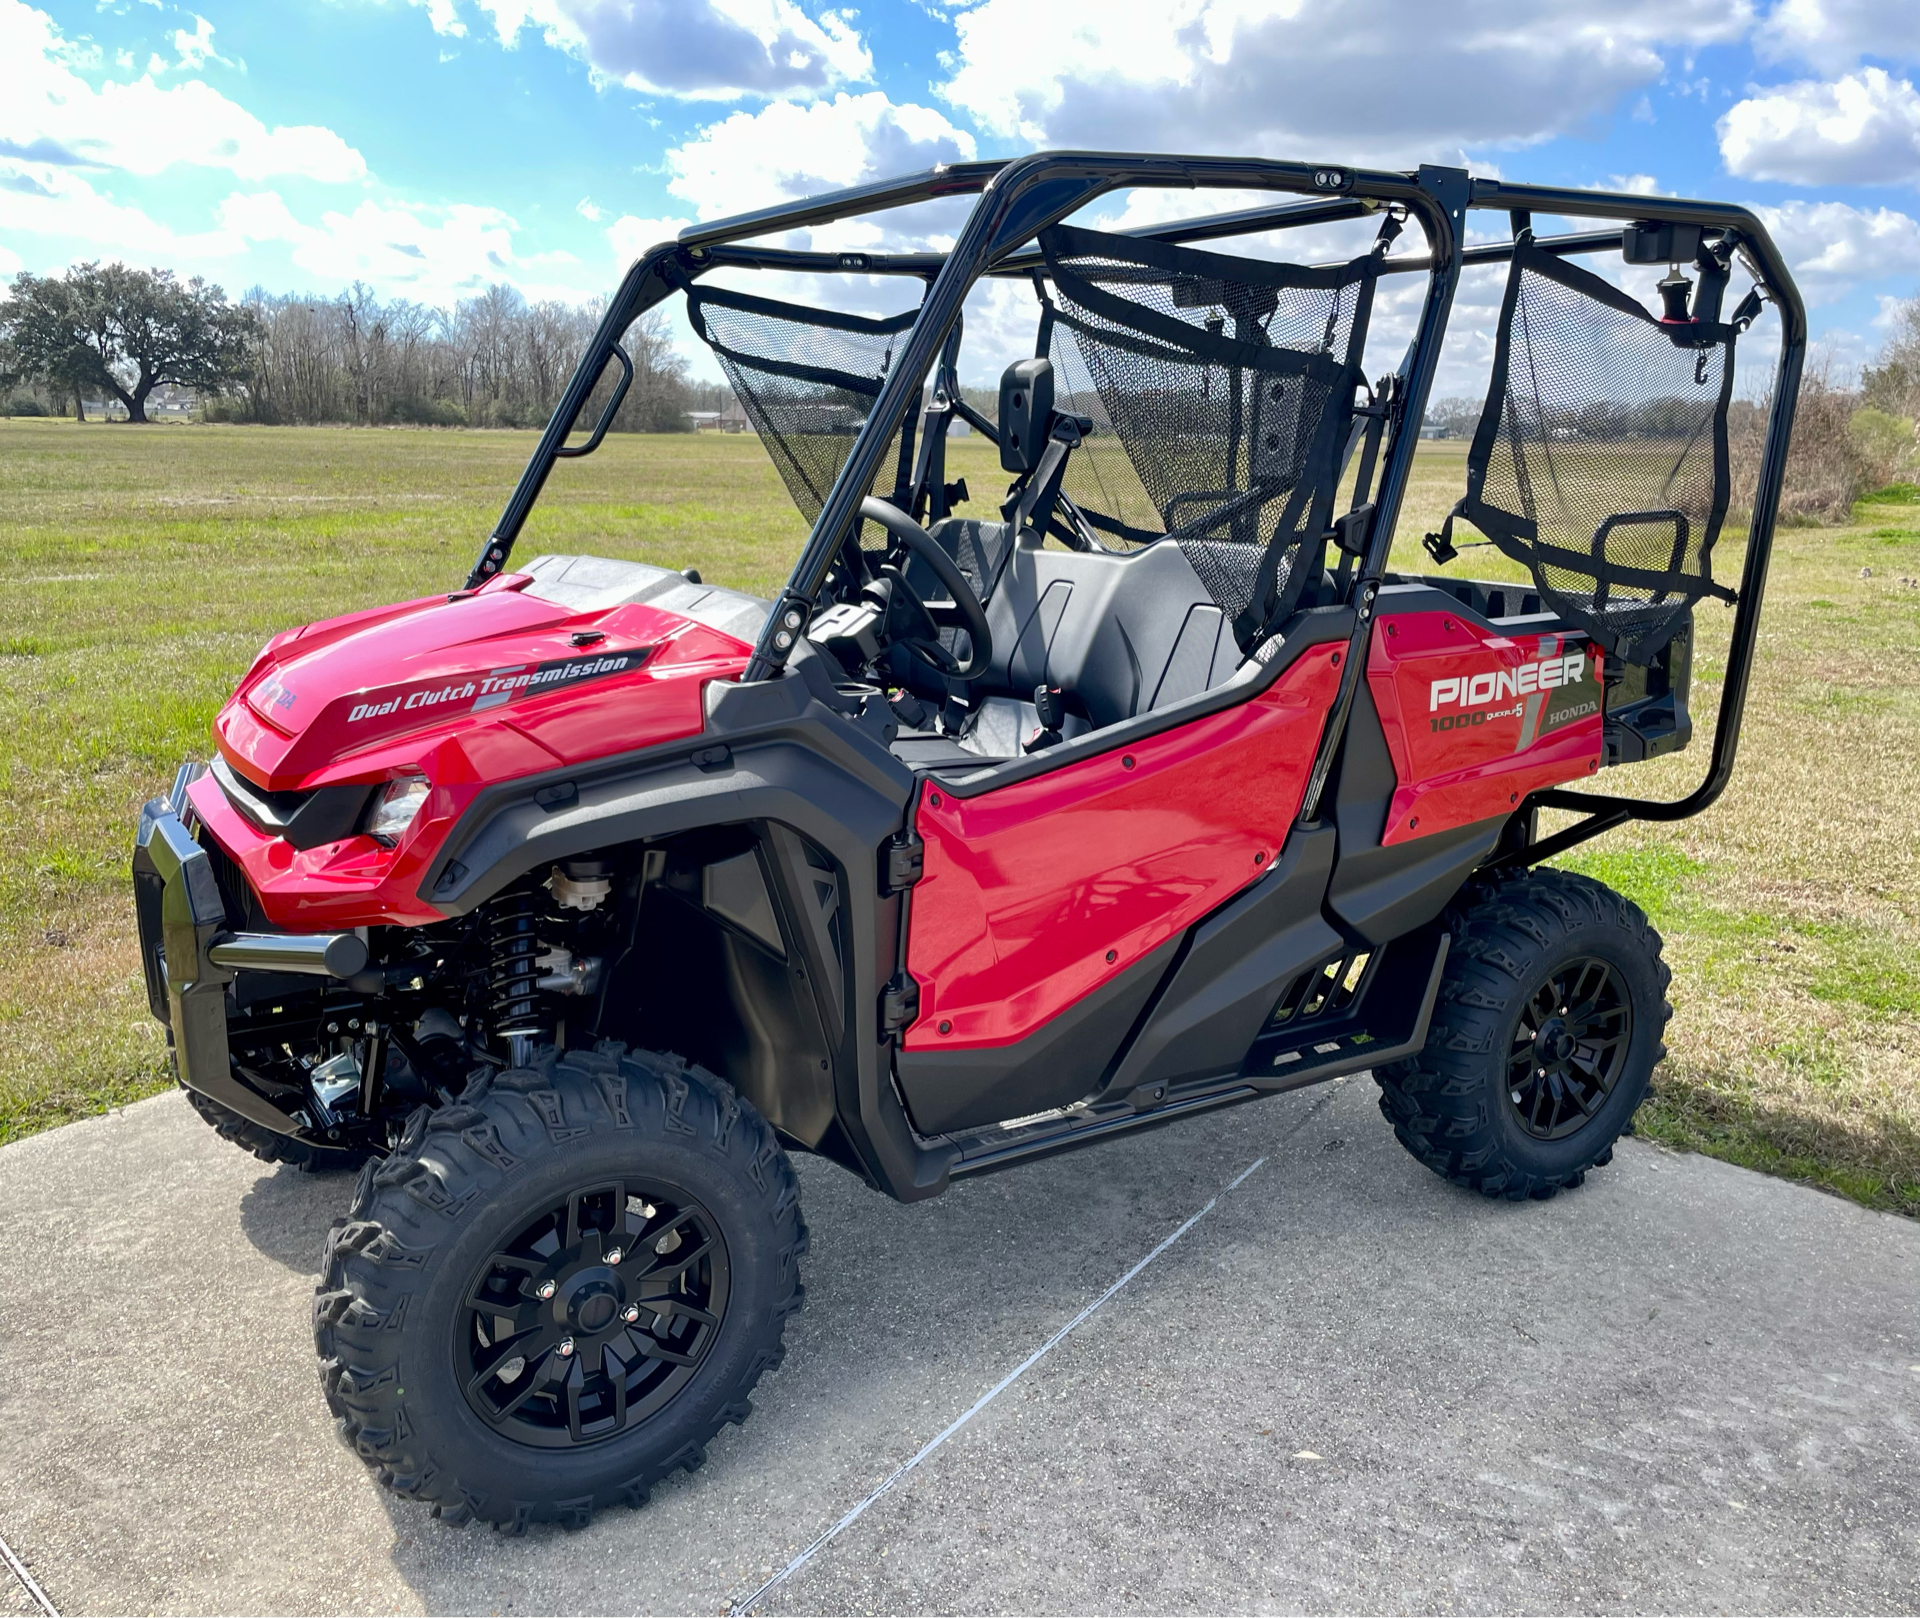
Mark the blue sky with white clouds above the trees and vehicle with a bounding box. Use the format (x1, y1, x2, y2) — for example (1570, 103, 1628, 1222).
(0, 0, 1920, 391)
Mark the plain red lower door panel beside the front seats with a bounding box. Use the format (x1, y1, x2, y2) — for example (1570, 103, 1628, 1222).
(906, 647, 1340, 1050)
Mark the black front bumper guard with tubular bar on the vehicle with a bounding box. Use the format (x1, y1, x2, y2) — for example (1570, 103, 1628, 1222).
(132, 764, 378, 1144)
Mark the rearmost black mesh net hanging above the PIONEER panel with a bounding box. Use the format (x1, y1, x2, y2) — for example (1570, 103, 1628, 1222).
(1436, 236, 1734, 662)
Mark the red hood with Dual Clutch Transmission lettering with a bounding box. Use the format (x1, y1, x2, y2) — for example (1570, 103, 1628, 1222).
(215, 557, 764, 791)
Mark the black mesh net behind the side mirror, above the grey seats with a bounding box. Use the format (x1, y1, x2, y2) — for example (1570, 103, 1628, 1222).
(1041, 225, 1379, 651)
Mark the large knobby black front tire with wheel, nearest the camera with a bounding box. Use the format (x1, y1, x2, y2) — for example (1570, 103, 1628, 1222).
(313, 1044, 806, 1530)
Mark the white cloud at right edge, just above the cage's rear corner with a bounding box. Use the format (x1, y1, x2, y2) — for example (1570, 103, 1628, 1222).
(1716, 67, 1920, 186)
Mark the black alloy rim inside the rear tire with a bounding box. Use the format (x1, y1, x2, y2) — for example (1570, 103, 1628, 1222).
(1507, 956, 1634, 1140)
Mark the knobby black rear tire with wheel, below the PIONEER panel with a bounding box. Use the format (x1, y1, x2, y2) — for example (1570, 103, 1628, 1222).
(1375, 869, 1672, 1202)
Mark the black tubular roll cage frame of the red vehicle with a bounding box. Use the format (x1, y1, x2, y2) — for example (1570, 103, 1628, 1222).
(467, 152, 1807, 864)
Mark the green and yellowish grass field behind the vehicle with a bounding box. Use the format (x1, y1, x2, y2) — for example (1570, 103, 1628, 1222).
(0, 422, 1920, 1215)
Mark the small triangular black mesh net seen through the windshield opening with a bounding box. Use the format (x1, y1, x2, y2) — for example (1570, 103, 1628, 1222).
(687, 286, 920, 522)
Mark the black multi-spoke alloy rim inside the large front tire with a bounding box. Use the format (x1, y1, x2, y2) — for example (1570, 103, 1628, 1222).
(453, 1180, 730, 1449)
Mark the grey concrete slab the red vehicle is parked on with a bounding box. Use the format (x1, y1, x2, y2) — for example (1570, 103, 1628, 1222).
(0, 1079, 1920, 1612)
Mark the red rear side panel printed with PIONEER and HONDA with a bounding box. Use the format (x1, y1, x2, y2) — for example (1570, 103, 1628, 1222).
(1367, 612, 1603, 843)
